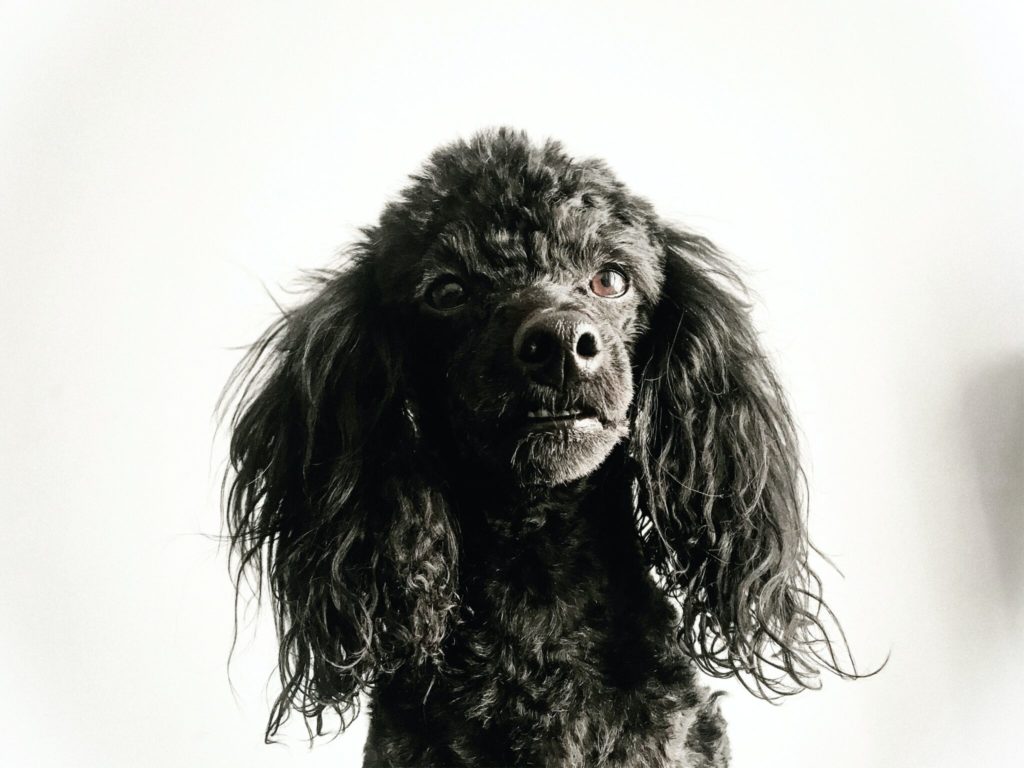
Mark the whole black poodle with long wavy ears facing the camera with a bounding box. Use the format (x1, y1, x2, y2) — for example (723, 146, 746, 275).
(225, 130, 853, 768)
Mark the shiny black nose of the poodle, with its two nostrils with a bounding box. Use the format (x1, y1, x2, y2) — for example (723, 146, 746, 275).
(512, 309, 604, 389)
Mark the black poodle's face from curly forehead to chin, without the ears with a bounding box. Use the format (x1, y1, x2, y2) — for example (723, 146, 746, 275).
(376, 145, 663, 485)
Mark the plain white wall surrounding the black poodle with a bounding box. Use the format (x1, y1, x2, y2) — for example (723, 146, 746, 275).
(0, 0, 1024, 768)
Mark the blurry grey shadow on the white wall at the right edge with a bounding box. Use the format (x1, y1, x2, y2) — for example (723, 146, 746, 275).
(965, 353, 1024, 620)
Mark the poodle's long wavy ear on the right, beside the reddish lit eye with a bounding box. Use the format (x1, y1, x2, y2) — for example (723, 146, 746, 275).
(631, 227, 856, 698)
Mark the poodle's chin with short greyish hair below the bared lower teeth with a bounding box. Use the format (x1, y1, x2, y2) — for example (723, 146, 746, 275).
(511, 419, 627, 486)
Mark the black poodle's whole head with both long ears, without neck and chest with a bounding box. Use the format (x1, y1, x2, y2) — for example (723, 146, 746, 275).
(225, 130, 864, 732)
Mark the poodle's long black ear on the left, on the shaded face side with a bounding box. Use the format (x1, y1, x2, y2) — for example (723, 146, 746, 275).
(224, 247, 457, 740)
